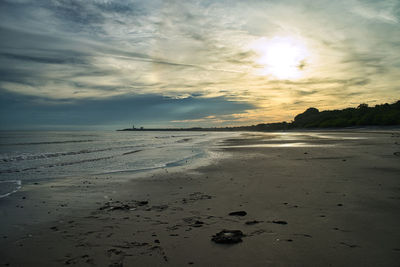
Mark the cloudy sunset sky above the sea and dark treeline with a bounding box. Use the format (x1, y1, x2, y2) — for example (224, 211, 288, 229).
(0, 0, 400, 130)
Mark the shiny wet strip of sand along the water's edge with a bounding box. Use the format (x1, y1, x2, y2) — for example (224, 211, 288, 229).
(0, 133, 234, 243)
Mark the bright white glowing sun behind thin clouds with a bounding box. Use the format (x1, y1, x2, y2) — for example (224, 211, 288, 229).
(253, 37, 309, 80)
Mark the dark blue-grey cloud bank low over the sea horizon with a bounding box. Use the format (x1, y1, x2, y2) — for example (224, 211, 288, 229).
(0, 91, 254, 129)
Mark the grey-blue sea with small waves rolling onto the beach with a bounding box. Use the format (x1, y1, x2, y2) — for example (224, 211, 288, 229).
(0, 131, 232, 198)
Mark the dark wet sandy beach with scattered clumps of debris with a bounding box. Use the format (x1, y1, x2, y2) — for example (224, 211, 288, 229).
(0, 130, 400, 266)
